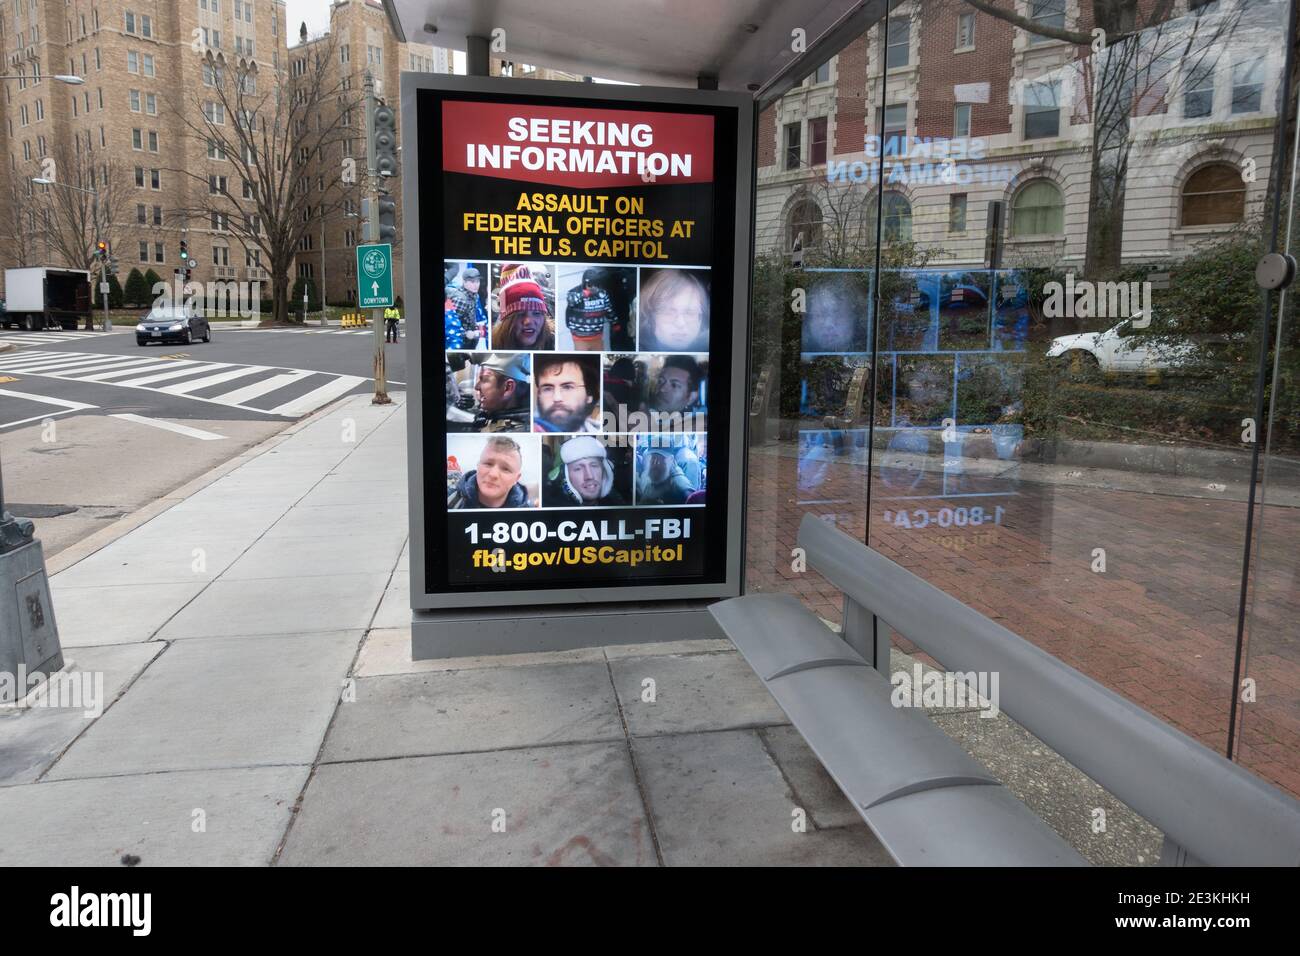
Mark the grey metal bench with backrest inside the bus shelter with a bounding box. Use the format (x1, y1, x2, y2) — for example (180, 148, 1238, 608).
(710, 515, 1300, 866)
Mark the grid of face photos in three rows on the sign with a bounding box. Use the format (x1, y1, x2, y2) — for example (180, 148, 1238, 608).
(443, 260, 711, 509)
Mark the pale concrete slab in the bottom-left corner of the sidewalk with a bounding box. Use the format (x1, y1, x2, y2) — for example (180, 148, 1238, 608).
(0, 766, 308, 866)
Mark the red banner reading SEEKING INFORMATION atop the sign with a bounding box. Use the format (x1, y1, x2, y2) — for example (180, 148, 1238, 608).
(442, 101, 714, 189)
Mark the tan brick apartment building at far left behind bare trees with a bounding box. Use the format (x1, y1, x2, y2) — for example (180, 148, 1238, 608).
(0, 0, 287, 297)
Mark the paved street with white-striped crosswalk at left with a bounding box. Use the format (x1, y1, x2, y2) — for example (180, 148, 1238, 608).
(0, 323, 406, 555)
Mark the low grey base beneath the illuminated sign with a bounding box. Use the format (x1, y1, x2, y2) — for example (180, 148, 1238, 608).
(411, 601, 725, 661)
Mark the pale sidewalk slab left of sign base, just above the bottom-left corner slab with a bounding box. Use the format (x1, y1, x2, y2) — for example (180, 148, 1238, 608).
(47, 631, 361, 779)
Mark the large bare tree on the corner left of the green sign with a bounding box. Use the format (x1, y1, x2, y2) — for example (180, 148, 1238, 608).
(177, 36, 364, 323)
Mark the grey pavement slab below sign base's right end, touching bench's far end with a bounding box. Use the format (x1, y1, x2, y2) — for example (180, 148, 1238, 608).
(610, 652, 789, 736)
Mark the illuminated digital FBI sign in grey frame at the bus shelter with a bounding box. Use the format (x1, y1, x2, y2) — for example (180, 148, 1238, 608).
(403, 75, 751, 609)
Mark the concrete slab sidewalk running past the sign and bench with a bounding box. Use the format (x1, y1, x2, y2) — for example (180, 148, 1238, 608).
(0, 394, 1160, 865)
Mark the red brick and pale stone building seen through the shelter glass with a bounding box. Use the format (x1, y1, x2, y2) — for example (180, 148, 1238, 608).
(757, 0, 1286, 268)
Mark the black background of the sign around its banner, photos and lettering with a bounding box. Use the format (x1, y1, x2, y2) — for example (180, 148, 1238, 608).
(416, 90, 749, 600)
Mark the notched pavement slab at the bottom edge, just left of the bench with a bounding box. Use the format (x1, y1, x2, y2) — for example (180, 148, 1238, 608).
(632, 731, 892, 866)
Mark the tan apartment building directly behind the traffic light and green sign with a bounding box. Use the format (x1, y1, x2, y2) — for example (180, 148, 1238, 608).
(289, 0, 451, 304)
